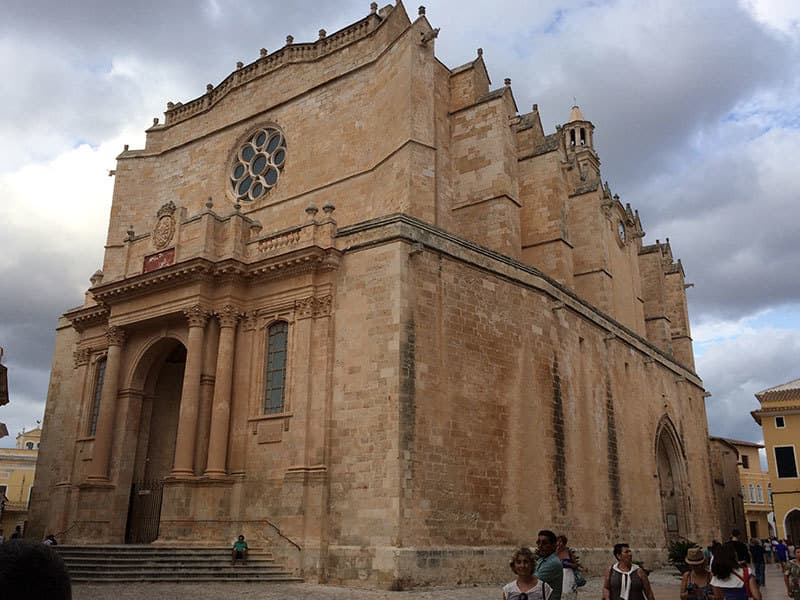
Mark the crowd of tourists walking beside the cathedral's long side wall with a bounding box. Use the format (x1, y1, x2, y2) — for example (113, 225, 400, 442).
(503, 530, 800, 600)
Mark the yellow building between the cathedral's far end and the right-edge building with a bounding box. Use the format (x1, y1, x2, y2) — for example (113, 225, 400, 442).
(723, 439, 772, 539)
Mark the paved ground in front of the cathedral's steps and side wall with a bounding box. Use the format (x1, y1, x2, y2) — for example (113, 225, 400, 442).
(73, 570, 688, 600)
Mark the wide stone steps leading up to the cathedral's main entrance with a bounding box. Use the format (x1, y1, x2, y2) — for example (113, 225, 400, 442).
(55, 544, 302, 583)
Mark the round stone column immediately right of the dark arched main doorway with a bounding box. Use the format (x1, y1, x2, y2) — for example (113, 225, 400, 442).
(171, 305, 208, 478)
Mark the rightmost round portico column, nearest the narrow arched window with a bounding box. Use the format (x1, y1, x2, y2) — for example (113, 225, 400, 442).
(205, 304, 241, 477)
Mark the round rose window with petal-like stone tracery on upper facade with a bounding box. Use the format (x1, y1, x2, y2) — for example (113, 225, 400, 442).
(230, 127, 286, 202)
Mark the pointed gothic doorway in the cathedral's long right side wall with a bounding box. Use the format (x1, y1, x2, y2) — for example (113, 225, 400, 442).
(656, 418, 689, 542)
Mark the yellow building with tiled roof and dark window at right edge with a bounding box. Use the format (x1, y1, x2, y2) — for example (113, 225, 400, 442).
(752, 379, 800, 543)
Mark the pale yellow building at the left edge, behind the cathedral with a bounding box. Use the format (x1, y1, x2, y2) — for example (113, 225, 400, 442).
(0, 427, 42, 538)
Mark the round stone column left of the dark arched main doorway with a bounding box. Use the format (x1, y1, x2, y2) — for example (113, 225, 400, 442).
(88, 326, 125, 482)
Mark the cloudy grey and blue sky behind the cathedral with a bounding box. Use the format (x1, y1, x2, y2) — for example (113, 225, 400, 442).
(0, 0, 800, 446)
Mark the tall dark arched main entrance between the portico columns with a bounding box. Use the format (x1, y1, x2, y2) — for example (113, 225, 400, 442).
(125, 339, 186, 544)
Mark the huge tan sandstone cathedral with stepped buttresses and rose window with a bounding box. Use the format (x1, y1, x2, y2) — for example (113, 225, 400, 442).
(31, 0, 718, 588)
